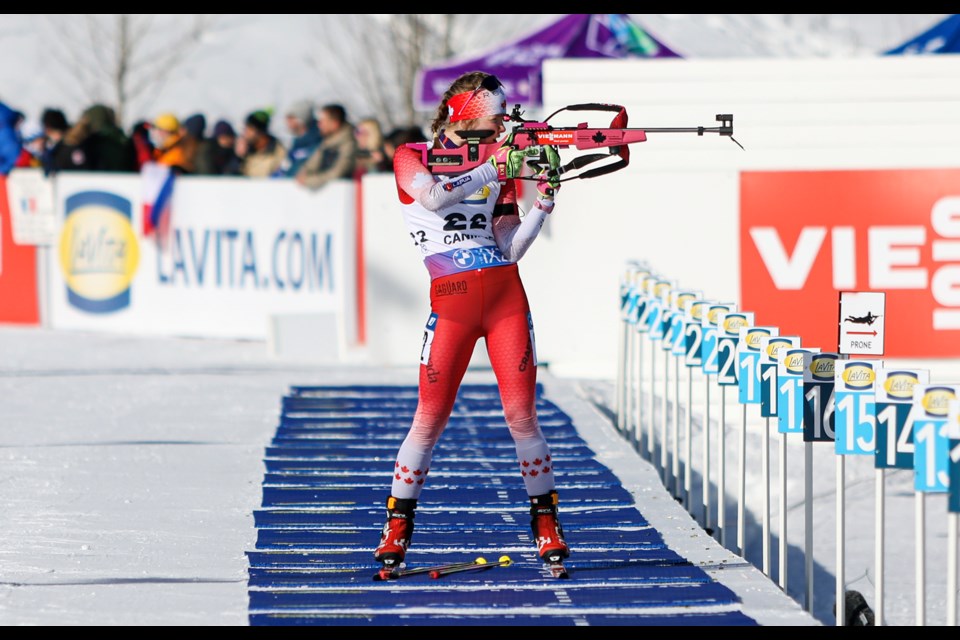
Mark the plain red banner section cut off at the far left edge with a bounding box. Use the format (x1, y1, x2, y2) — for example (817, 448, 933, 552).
(0, 176, 40, 324)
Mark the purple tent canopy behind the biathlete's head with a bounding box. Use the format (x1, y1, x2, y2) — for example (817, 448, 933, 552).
(415, 13, 680, 110)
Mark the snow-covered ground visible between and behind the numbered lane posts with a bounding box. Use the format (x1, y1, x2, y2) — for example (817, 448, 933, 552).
(580, 344, 960, 626)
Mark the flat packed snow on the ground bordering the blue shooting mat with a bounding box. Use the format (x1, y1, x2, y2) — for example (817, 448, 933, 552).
(0, 327, 814, 626)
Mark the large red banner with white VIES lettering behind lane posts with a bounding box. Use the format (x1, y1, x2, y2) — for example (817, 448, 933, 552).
(740, 169, 960, 358)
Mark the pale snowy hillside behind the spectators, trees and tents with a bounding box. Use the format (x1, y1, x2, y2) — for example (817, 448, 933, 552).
(0, 14, 948, 136)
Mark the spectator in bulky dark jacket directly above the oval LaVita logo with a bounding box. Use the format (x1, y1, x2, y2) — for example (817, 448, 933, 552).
(53, 104, 136, 171)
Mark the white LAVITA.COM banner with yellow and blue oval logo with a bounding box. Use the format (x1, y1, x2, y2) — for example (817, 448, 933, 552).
(49, 173, 354, 339)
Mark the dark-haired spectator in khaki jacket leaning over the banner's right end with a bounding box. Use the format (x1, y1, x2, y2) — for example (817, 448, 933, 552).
(296, 104, 357, 189)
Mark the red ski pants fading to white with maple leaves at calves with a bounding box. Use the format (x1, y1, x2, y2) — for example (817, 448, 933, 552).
(391, 264, 555, 499)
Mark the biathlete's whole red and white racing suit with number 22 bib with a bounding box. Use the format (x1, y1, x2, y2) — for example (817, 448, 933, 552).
(391, 136, 554, 499)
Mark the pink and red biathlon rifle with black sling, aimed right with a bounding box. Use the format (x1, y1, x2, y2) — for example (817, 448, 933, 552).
(408, 103, 743, 182)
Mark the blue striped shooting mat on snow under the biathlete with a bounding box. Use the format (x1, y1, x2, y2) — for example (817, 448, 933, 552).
(247, 385, 757, 626)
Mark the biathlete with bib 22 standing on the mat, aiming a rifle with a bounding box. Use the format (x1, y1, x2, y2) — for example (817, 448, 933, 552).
(374, 71, 569, 569)
